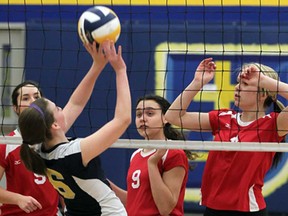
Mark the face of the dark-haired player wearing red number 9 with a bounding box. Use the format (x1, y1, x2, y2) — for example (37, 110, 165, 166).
(135, 100, 166, 139)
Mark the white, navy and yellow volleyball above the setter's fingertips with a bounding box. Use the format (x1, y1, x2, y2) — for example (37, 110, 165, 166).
(78, 6, 121, 44)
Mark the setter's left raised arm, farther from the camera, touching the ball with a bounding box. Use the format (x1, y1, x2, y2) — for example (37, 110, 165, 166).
(63, 42, 107, 132)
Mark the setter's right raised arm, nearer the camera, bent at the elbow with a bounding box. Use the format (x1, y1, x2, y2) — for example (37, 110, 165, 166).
(81, 41, 131, 166)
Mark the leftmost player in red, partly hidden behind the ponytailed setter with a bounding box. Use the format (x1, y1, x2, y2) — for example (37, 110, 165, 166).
(0, 81, 59, 216)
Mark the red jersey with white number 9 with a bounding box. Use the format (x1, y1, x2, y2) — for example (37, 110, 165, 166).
(126, 149, 189, 216)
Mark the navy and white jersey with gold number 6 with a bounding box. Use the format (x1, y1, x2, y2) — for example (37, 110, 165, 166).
(38, 139, 127, 216)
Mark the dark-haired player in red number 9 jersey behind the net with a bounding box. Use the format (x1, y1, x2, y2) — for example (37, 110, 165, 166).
(111, 95, 197, 216)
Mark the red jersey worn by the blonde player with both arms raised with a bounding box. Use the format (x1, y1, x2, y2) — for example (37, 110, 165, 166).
(201, 110, 283, 212)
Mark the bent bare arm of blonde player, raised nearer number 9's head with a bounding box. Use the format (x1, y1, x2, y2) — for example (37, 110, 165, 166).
(165, 58, 216, 131)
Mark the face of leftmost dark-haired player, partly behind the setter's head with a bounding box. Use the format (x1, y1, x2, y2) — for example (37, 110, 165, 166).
(14, 85, 41, 115)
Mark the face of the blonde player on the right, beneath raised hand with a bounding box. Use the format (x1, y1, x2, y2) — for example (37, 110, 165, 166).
(234, 68, 260, 111)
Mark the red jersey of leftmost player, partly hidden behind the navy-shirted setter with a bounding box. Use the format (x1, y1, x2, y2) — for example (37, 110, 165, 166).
(0, 130, 59, 216)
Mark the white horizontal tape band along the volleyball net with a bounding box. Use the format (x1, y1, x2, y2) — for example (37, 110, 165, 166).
(0, 136, 288, 152)
